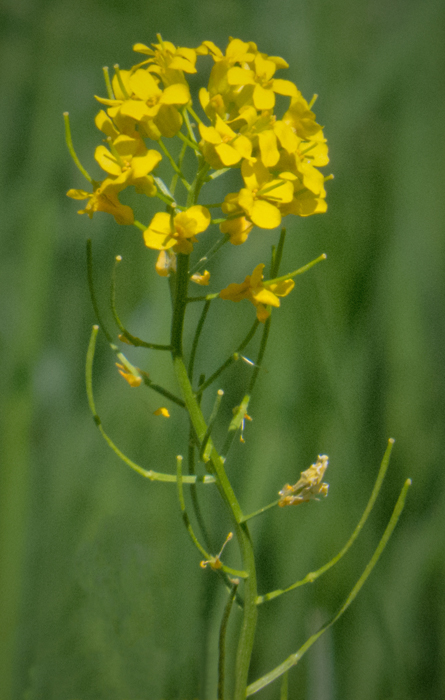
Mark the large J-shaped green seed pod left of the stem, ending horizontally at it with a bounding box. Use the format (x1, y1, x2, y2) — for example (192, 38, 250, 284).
(85, 326, 215, 484)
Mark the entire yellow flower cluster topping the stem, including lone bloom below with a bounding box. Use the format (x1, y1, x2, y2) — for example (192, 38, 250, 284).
(67, 35, 329, 322)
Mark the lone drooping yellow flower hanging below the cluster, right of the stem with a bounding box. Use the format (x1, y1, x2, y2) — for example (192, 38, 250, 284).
(219, 263, 295, 323)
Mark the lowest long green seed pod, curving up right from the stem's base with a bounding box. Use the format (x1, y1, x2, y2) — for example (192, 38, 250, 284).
(246, 479, 411, 697)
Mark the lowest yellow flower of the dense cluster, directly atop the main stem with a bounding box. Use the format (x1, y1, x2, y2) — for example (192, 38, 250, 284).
(144, 204, 211, 255)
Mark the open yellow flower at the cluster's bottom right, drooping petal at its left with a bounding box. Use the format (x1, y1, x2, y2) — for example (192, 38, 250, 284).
(220, 159, 294, 242)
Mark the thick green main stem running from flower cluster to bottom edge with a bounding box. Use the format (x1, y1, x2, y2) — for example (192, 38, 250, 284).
(171, 253, 257, 700)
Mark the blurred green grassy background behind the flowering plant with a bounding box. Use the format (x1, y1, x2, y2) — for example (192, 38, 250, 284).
(0, 0, 445, 700)
